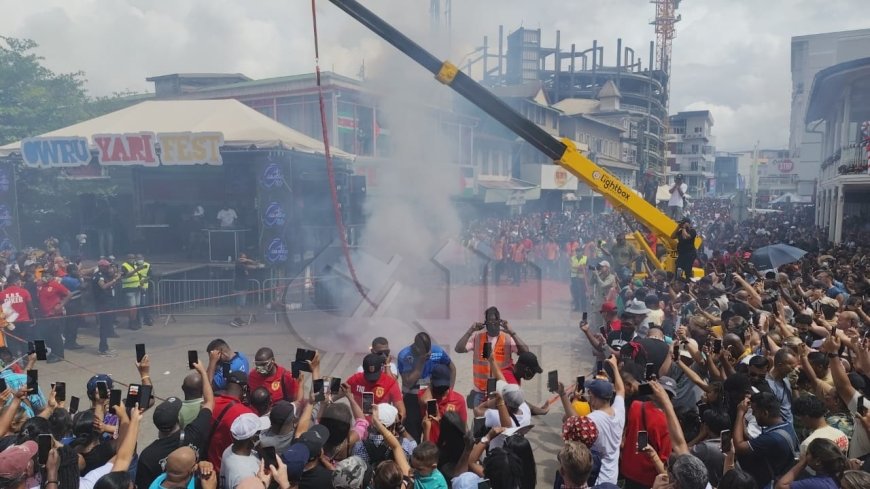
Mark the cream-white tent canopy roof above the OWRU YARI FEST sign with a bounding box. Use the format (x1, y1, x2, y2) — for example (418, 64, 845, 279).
(0, 99, 353, 159)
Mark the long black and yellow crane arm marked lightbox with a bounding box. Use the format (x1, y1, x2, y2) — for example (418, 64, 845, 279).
(330, 0, 700, 252)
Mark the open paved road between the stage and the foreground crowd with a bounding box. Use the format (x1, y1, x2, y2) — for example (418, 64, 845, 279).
(29, 281, 594, 487)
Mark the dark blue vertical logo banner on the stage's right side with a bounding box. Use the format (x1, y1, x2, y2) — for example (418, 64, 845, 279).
(257, 156, 293, 267)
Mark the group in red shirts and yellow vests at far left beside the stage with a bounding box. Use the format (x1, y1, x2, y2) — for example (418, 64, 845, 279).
(0, 248, 154, 363)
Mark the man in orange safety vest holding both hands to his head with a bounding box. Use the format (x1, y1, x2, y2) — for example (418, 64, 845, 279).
(454, 307, 529, 408)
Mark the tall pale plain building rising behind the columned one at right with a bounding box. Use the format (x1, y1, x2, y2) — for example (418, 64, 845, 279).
(781, 29, 870, 196)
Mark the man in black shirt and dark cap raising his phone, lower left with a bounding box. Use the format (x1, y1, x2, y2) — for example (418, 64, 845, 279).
(136, 362, 214, 487)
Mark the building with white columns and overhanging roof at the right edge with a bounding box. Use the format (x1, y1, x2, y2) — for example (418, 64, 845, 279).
(805, 57, 870, 242)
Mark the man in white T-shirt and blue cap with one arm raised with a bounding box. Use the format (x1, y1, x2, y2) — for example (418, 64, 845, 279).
(586, 355, 625, 485)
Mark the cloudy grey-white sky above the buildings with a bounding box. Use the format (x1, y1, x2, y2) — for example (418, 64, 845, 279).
(0, 0, 870, 151)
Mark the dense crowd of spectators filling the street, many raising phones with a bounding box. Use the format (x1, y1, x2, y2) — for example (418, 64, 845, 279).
(0, 201, 870, 489)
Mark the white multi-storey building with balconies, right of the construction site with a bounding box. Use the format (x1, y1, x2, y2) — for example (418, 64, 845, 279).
(668, 110, 717, 197)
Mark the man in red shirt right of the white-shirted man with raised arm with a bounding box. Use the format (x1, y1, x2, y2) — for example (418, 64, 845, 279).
(619, 377, 677, 488)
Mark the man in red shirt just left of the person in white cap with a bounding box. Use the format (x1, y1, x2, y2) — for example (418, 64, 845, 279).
(207, 371, 254, 474)
